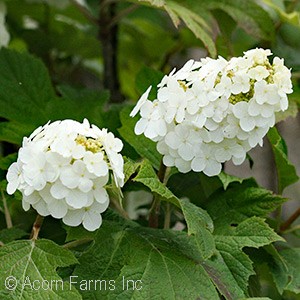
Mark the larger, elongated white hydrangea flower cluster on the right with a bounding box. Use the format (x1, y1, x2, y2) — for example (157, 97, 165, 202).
(130, 49, 292, 176)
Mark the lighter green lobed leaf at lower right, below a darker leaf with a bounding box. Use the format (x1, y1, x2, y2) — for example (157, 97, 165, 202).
(205, 217, 283, 299)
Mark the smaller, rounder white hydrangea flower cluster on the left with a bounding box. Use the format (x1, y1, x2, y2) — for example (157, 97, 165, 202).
(6, 119, 124, 231)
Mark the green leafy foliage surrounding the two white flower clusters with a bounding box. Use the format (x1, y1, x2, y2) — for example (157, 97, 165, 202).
(0, 0, 300, 300)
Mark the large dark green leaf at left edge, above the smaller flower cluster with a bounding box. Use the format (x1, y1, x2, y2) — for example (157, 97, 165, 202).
(0, 48, 55, 126)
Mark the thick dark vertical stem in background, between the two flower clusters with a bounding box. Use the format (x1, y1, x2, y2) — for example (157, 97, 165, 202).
(98, 0, 123, 103)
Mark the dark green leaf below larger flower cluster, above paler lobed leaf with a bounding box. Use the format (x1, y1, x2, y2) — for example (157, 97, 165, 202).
(206, 181, 286, 234)
